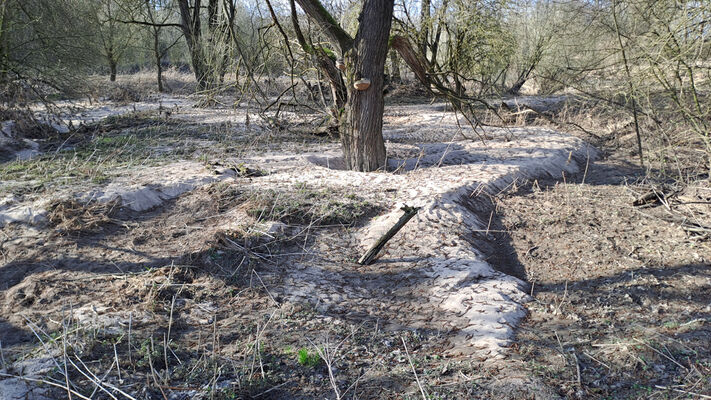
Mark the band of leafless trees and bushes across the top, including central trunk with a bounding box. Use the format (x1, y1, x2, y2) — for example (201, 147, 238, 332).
(0, 0, 711, 171)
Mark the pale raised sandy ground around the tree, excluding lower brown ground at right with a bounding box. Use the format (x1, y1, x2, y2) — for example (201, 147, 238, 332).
(0, 92, 708, 398)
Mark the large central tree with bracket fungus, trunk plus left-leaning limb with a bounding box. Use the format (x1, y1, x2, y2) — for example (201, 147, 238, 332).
(292, 0, 394, 172)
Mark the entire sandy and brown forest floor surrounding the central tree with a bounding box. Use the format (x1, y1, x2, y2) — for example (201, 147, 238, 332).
(0, 79, 711, 399)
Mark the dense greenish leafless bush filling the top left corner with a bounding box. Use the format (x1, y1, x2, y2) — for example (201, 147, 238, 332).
(0, 0, 100, 103)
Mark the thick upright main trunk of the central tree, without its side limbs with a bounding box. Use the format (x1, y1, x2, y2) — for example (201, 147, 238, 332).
(340, 0, 394, 172)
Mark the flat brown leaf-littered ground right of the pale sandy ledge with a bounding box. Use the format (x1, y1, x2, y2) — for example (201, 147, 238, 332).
(497, 157, 711, 398)
